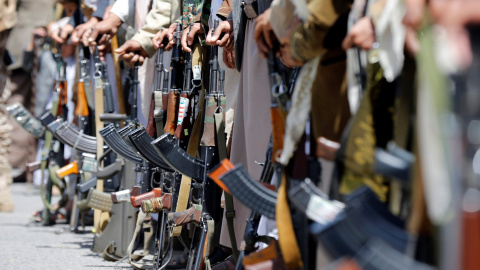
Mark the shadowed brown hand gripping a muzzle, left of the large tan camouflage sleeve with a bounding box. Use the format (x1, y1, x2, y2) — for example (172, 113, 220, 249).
(253, 8, 276, 58)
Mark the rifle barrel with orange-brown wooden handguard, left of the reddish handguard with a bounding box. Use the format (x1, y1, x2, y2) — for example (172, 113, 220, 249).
(164, 24, 183, 135)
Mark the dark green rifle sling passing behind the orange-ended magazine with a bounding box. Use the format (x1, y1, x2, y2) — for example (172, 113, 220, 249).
(214, 112, 238, 261)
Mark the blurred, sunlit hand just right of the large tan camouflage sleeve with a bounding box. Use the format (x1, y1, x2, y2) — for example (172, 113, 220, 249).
(342, 17, 375, 50)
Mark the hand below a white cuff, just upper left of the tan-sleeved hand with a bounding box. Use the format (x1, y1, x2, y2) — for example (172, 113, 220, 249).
(82, 13, 123, 47)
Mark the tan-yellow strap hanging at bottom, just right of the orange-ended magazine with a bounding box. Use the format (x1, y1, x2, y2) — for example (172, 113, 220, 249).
(276, 173, 303, 269)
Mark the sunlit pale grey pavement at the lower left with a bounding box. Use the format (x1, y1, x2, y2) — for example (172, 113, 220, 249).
(0, 183, 132, 270)
